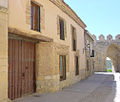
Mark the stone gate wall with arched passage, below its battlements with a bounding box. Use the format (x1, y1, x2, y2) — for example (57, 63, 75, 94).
(95, 42, 120, 72)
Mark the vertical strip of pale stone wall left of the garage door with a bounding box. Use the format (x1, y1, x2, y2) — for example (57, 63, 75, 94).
(0, 0, 8, 102)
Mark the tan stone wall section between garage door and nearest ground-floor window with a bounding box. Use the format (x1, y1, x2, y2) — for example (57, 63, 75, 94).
(36, 42, 59, 93)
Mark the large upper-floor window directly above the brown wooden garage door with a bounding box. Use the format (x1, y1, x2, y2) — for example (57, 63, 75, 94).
(31, 2, 40, 32)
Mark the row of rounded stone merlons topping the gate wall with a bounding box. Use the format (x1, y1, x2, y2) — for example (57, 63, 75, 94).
(92, 34, 120, 41)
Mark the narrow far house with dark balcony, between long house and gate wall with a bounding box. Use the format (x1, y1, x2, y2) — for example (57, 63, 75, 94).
(85, 30, 94, 77)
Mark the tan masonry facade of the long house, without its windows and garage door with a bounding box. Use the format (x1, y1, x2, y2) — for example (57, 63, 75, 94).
(0, 0, 93, 102)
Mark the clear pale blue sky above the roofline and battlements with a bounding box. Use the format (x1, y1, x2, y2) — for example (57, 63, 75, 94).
(64, 0, 120, 37)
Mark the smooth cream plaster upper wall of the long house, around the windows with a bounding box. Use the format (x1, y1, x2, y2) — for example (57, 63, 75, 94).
(9, 0, 85, 77)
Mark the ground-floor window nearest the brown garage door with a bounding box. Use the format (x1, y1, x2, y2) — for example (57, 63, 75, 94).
(59, 55, 66, 81)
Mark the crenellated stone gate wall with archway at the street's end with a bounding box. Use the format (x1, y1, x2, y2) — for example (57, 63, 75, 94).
(94, 34, 120, 71)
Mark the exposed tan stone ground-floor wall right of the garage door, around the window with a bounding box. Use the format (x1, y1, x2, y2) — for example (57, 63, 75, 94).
(36, 42, 86, 93)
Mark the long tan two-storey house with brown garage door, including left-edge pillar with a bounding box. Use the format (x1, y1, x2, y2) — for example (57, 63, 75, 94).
(0, 0, 93, 102)
